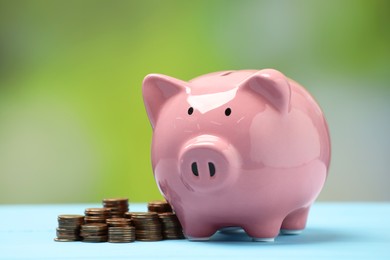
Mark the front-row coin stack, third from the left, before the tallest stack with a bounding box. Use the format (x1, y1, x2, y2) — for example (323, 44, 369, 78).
(107, 218, 135, 243)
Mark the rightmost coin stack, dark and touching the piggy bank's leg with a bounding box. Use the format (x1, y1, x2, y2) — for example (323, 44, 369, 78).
(158, 212, 184, 239)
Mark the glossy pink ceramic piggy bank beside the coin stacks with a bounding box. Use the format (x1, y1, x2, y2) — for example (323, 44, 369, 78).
(142, 69, 330, 241)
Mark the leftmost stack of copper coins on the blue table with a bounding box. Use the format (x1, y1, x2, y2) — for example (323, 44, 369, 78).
(54, 214, 84, 242)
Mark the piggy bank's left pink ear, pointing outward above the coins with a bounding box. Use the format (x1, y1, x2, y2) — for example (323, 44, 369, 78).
(142, 74, 186, 128)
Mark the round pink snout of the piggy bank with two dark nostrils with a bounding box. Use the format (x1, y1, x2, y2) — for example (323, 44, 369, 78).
(180, 135, 239, 190)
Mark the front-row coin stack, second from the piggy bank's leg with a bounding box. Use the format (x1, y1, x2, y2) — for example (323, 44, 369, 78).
(126, 212, 163, 241)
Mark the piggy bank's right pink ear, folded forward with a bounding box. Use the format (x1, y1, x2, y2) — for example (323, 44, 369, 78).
(240, 69, 291, 114)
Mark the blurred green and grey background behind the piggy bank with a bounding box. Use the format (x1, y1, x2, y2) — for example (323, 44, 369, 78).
(0, 0, 390, 203)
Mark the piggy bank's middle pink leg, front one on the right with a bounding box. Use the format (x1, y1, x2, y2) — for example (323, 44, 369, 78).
(243, 219, 282, 242)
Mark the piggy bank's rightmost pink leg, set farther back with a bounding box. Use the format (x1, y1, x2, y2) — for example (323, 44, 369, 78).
(280, 206, 310, 235)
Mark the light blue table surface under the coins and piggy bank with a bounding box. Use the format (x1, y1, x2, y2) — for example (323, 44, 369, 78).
(0, 203, 390, 260)
